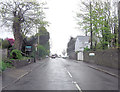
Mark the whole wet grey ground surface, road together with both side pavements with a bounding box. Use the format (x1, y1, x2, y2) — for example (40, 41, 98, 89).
(2, 58, 118, 92)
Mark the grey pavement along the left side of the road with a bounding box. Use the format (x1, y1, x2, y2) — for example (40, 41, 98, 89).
(0, 60, 47, 89)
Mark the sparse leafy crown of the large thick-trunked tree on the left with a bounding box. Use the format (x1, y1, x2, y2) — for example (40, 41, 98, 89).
(0, 0, 47, 35)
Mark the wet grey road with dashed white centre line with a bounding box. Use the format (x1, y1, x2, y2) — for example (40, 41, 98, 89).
(2, 58, 118, 92)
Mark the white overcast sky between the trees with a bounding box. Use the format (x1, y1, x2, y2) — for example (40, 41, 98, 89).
(0, 0, 83, 54)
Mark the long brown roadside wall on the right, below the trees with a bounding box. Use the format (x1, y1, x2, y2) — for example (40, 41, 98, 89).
(83, 49, 120, 69)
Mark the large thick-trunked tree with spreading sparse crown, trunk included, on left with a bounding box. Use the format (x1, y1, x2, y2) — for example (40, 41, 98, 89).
(0, 0, 47, 50)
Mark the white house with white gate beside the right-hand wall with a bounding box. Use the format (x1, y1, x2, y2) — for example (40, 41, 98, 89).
(75, 36, 90, 60)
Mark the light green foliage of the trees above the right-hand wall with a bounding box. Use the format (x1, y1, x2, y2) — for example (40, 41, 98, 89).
(77, 0, 118, 49)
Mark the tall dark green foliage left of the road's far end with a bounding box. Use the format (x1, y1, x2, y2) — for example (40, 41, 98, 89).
(32, 26, 50, 57)
